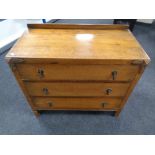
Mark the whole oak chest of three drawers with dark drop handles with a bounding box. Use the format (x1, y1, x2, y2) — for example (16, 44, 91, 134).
(6, 24, 150, 116)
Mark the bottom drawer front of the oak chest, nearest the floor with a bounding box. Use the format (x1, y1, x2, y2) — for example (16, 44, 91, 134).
(33, 97, 121, 110)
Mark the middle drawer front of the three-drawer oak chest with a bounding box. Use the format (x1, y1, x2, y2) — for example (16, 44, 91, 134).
(25, 82, 129, 96)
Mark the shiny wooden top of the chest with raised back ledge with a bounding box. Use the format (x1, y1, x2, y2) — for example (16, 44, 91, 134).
(6, 24, 150, 64)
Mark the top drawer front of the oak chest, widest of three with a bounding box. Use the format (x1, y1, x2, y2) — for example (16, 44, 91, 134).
(17, 64, 138, 81)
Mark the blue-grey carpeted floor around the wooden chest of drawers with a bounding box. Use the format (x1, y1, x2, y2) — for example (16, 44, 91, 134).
(0, 20, 155, 134)
